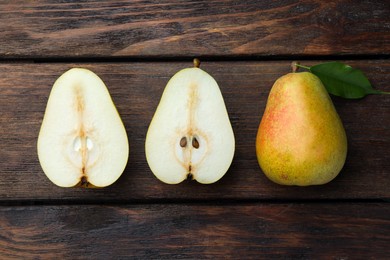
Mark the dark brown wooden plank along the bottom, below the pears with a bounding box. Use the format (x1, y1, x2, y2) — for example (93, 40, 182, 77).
(0, 203, 390, 259)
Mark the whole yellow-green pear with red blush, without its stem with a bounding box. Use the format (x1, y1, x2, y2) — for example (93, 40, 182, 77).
(256, 72, 347, 186)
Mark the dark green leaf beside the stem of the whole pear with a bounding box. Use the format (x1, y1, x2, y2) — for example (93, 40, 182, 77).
(310, 62, 390, 99)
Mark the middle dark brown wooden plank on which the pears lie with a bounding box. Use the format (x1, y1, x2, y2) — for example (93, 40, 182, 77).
(0, 60, 390, 201)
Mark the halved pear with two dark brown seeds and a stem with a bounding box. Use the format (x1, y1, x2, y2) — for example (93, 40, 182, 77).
(145, 59, 235, 184)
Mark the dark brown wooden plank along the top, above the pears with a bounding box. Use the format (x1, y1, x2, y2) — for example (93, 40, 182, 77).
(0, 0, 390, 59)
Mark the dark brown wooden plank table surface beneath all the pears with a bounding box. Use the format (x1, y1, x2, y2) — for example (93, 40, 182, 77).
(0, 0, 390, 259)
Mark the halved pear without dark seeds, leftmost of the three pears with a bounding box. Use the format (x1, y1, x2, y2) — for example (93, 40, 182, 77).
(38, 68, 129, 187)
